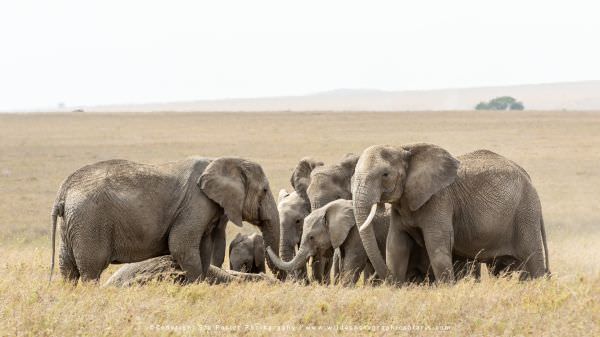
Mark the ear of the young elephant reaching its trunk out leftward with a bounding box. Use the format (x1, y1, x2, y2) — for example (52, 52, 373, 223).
(324, 200, 356, 249)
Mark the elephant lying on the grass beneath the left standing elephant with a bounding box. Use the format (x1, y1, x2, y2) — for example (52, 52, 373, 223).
(104, 255, 277, 287)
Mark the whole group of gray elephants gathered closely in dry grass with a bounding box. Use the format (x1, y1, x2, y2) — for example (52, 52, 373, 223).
(50, 143, 550, 285)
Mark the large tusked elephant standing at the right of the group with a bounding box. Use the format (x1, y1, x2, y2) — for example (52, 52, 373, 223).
(352, 144, 550, 283)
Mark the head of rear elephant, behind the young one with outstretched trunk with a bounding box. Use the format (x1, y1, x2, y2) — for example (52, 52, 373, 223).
(306, 154, 358, 210)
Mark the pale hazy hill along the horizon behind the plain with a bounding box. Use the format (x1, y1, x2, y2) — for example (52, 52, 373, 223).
(84, 81, 600, 112)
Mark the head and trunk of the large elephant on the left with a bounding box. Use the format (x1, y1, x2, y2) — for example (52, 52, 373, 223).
(198, 158, 283, 278)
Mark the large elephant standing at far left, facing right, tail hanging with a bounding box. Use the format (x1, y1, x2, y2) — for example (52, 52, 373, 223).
(50, 158, 279, 282)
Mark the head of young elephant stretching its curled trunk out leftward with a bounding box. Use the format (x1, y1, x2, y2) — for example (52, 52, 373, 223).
(267, 199, 356, 271)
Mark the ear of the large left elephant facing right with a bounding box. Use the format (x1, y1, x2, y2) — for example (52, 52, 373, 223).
(198, 158, 246, 227)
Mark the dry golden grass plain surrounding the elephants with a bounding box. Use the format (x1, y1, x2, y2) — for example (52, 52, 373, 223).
(0, 111, 600, 336)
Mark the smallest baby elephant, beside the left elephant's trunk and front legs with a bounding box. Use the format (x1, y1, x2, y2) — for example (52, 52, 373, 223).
(229, 233, 265, 274)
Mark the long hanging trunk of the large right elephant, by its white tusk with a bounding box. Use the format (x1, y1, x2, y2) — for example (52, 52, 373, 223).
(353, 178, 389, 280)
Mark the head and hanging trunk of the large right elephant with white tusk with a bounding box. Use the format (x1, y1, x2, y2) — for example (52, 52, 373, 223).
(352, 144, 459, 278)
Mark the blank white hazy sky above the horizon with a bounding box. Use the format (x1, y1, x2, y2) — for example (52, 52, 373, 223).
(0, 0, 600, 110)
